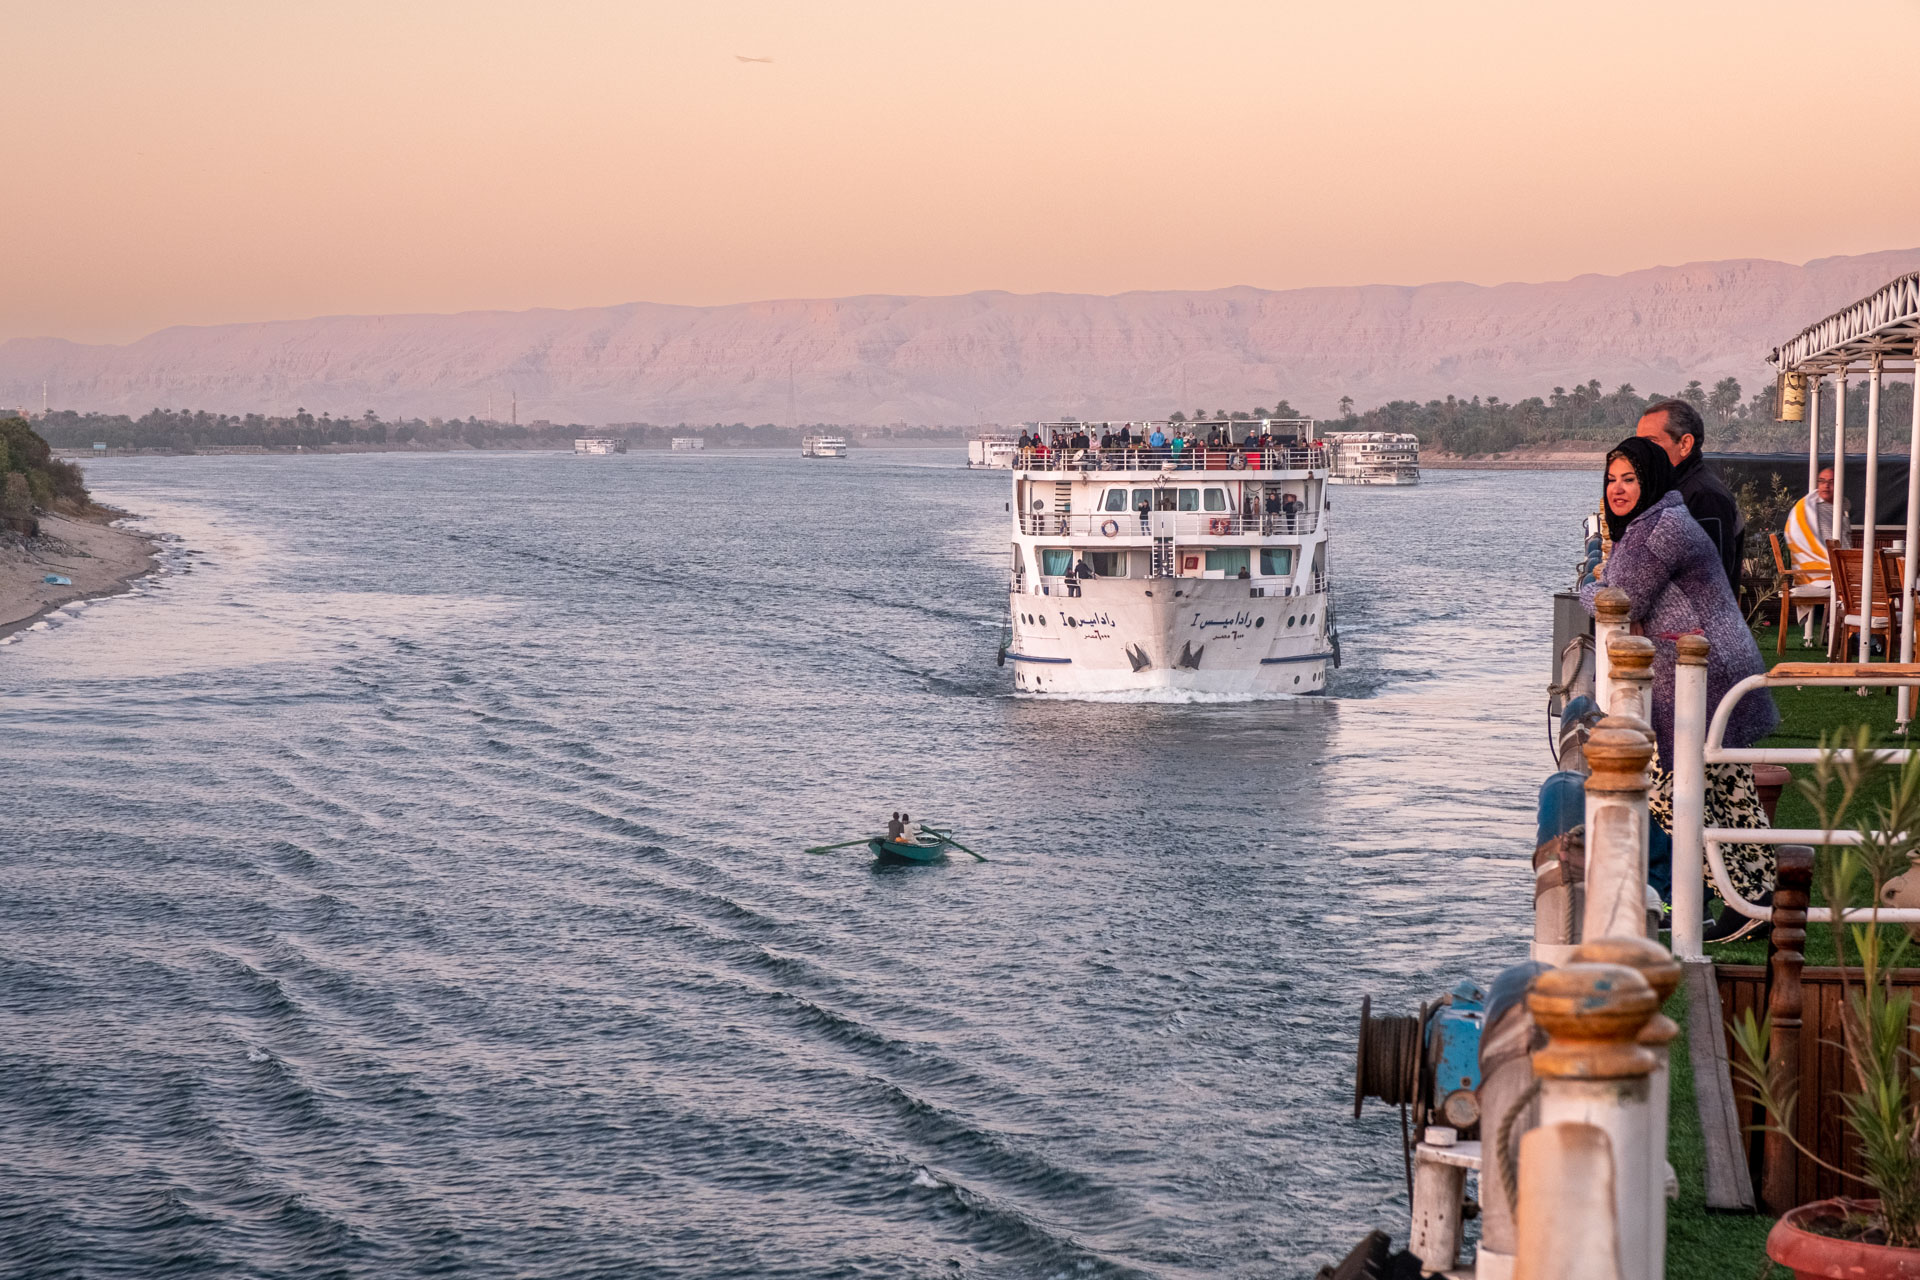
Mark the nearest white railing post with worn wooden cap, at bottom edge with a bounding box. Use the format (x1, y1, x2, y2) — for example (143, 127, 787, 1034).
(1513, 965, 1661, 1280)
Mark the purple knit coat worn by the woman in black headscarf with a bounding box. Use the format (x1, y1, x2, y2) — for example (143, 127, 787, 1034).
(1580, 489, 1780, 770)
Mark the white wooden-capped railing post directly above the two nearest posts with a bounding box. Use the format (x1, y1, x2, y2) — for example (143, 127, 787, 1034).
(1580, 716, 1653, 938)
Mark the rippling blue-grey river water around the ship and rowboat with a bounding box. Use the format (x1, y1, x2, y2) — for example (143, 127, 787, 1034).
(0, 451, 1594, 1280)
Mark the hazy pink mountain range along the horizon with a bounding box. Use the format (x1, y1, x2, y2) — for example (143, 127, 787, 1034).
(0, 249, 1920, 426)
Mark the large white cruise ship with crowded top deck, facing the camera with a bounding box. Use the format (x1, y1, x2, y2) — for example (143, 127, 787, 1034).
(1002, 418, 1338, 697)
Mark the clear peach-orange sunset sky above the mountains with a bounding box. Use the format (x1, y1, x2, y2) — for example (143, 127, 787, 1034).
(0, 0, 1920, 342)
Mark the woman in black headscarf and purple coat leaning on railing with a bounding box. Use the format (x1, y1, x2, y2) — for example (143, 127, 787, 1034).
(1580, 436, 1780, 942)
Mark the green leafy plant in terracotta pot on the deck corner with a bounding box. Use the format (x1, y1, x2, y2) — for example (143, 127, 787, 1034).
(1734, 727, 1920, 1280)
